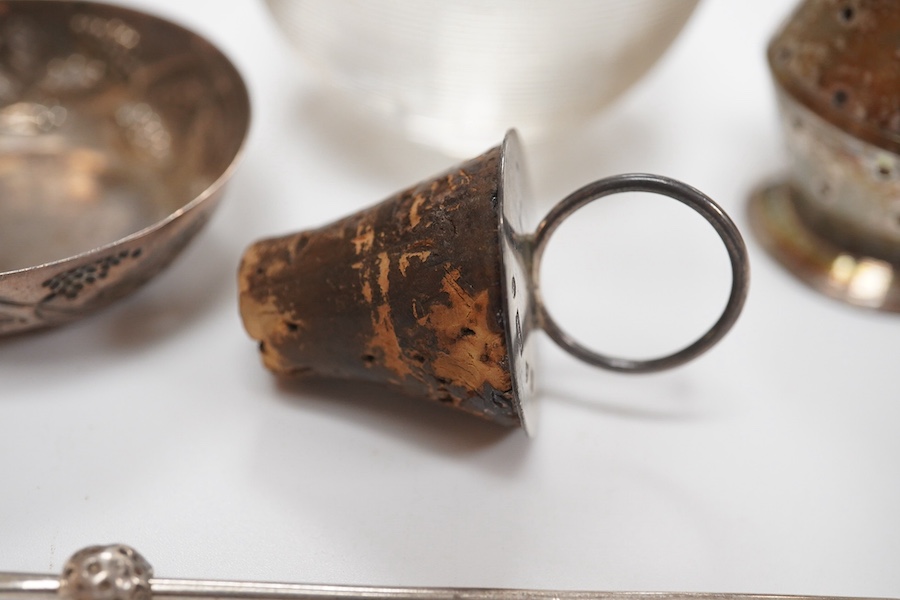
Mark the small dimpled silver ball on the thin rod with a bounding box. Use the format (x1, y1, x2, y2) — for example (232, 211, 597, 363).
(59, 544, 153, 600)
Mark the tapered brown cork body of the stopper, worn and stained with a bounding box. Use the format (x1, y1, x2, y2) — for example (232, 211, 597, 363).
(239, 148, 519, 426)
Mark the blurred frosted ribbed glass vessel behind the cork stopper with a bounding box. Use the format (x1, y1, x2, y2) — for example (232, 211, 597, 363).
(266, 0, 697, 154)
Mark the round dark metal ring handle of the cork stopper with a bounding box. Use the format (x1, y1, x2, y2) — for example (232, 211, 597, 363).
(531, 173, 750, 373)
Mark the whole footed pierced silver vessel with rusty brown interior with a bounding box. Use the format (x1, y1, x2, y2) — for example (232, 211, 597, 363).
(749, 0, 900, 312)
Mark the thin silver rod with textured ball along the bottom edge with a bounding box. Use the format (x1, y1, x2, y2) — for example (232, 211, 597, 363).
(0, 544, 892, 600)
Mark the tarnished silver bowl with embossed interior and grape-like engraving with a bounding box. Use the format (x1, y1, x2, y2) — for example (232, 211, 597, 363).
(0, 1, 250, 335)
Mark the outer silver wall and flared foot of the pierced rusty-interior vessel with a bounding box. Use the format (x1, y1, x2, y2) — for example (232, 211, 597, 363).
(749, 90, 900, 312)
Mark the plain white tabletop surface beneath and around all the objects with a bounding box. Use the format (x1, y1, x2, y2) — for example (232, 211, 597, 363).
(0, 0, 900, 597)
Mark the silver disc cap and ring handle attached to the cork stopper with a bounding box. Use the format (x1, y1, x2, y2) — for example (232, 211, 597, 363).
(500, 131, 750, 432)
